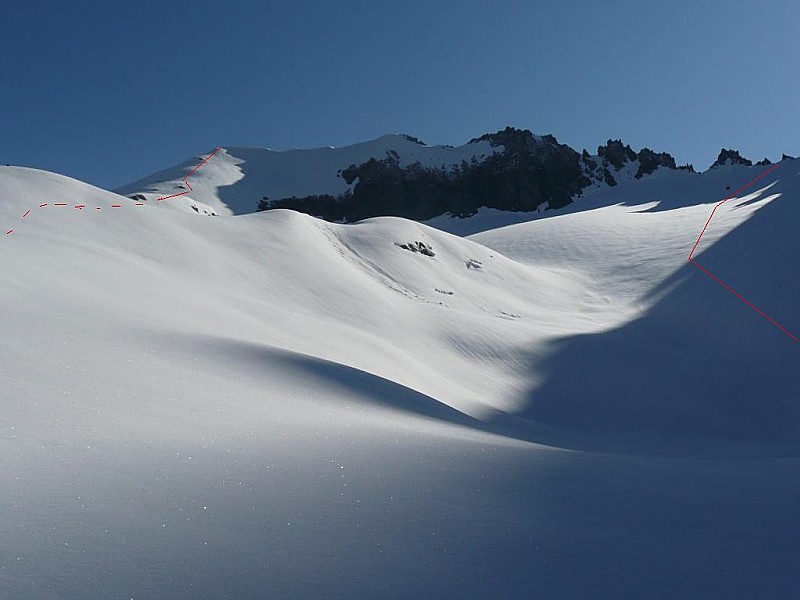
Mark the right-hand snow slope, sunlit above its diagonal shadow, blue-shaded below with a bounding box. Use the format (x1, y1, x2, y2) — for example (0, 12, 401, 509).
(470, 160, 800, 452)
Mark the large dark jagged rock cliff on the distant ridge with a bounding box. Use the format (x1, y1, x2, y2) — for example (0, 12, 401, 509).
(258, 127, 676, 222)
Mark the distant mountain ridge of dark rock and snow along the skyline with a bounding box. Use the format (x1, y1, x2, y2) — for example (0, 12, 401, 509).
(116, 127, 780, 222)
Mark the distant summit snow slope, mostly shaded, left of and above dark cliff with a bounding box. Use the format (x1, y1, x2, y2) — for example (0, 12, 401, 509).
(117, 134, 502, 215)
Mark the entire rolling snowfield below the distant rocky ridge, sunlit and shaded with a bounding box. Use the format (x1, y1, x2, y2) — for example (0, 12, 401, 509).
(0, 160, 800, 600)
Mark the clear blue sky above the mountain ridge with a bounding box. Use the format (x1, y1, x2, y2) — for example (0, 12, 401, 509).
(0, 0, 800, 187)
